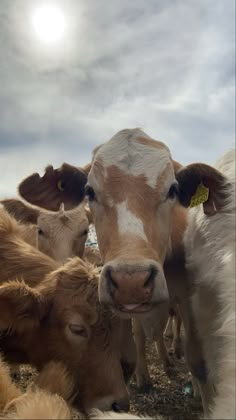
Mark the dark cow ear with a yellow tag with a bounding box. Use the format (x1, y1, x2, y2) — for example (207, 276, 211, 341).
(176, 163, 227, 216)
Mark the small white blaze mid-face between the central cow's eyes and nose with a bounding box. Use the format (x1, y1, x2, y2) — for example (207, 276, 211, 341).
(116, 201, 147, 241)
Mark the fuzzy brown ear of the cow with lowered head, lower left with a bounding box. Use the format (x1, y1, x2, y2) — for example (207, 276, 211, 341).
(0, 280, 50, 333)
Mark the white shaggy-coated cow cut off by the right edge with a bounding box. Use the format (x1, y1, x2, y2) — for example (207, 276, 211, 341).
(182, 150, 236, 419)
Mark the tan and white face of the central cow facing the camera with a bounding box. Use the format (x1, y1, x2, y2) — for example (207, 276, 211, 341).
(86, 129, 177, 313)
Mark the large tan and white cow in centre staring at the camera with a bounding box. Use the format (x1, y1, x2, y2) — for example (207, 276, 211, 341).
(19, 129, 222, 414)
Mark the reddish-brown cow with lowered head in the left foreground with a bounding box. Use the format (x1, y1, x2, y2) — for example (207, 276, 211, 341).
(0, 258, 135, 411)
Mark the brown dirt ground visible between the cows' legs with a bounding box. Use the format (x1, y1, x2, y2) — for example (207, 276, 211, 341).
(12, 334, 202, 420)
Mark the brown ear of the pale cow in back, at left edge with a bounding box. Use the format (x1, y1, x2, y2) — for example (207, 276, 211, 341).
(0, 198, 40, 225)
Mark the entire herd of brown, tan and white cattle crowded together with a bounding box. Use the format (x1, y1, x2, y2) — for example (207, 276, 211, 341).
(0, 129, 236, 419)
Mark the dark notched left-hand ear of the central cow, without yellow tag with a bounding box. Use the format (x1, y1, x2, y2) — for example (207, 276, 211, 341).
(18, 163, 89, 211)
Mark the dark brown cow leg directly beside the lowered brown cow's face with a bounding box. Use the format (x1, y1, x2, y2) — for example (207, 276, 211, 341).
(121, 319, 137, 383)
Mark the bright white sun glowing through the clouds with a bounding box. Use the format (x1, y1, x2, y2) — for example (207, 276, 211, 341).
(32, 5, 66, 44)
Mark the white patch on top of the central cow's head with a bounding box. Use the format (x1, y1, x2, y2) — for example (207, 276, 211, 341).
(95, 128, 171, 188)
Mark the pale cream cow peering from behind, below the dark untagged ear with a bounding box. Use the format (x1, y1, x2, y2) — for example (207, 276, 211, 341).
(1, 199, 91, 262)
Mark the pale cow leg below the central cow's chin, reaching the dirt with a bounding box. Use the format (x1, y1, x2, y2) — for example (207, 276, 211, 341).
(133, 319, 152, 392)
